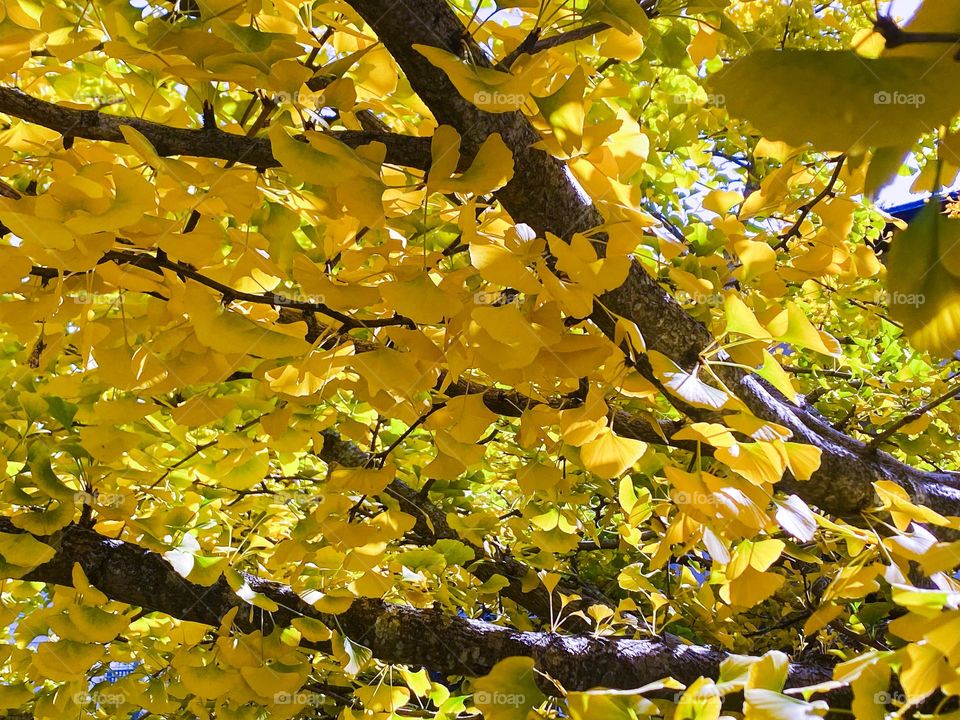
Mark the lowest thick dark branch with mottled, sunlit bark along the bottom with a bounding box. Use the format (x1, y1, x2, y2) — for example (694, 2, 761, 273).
(0, 518, 832, 690)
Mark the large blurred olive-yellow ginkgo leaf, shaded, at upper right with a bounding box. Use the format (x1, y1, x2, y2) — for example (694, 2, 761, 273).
(712, 49, 960, 150)
